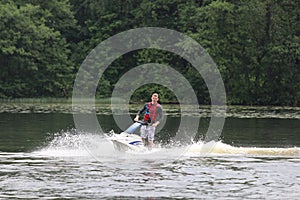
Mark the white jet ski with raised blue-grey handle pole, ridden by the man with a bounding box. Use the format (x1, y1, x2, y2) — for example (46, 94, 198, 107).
(109, 121, 147, 151)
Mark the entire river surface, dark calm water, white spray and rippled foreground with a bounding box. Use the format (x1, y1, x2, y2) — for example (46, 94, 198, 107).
(0, 104, 300, 199)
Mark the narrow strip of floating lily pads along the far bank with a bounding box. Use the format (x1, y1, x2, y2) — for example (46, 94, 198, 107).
(0, 99, 300, 119)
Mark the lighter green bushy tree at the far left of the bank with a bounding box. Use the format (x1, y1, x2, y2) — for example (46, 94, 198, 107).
(0, 1, 72, 98)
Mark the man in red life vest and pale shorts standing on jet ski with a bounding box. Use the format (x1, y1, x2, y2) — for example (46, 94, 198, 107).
(134, 93, 163, 149)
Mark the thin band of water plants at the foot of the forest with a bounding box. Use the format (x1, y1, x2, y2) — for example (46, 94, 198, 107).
(0, 101, 300, 119)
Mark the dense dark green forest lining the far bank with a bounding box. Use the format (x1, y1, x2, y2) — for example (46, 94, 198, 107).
(0, 0, 300, 106)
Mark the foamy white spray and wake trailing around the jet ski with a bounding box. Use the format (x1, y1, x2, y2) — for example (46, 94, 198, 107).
(32, 130, 300, 161)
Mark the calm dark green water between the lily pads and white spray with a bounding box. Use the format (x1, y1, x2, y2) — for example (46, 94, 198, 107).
(0, 113, 300, 152)
